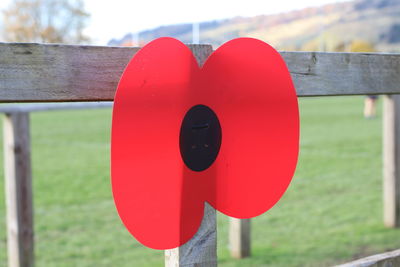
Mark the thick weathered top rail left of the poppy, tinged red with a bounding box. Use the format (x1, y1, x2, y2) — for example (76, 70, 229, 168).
(0, 43, 212, 102)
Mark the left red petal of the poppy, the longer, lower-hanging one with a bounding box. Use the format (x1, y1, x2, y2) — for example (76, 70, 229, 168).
(111, 38, 204, 249)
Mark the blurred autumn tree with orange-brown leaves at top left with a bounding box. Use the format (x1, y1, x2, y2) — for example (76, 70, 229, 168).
(2, 0, 90, 44)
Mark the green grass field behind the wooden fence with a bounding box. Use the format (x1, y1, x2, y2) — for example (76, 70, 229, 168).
(0, 97, 400, 267)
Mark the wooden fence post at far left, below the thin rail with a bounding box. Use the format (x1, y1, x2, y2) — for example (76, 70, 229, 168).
(3, 113, 34, 267)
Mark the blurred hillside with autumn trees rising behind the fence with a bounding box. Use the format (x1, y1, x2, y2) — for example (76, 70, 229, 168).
(108, 0, 400, 52)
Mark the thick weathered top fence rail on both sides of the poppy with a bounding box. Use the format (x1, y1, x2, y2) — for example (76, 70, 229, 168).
(0, 43, 400, 102)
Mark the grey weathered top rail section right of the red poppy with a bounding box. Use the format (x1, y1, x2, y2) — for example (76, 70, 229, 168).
(281, 52, 400, 96)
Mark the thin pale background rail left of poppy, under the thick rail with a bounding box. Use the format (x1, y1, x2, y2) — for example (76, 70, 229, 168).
(0, 102, 113, 113)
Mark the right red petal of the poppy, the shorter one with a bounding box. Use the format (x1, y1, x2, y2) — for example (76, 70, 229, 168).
(202, 38, 299, 218)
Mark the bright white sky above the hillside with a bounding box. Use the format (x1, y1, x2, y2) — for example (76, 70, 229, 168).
(0, 0, 345, 45)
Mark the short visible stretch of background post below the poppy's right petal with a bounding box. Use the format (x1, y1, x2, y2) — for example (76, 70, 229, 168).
(229, 218, 251, 259)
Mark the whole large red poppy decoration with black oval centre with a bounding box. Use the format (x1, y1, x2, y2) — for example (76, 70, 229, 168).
(111, 38, 299, 249)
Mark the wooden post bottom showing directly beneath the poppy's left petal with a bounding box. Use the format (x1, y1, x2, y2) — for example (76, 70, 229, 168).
(165, 203, 217, 267)
